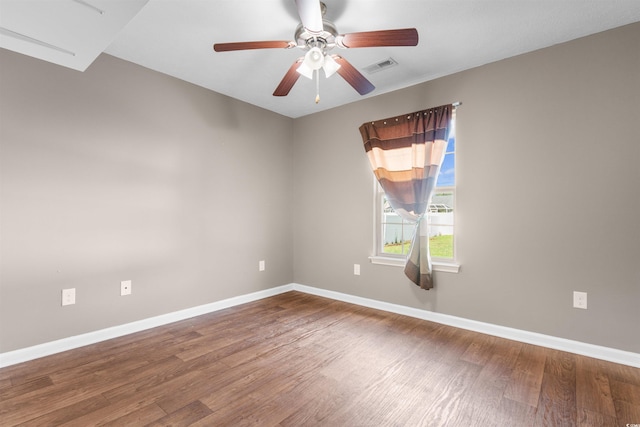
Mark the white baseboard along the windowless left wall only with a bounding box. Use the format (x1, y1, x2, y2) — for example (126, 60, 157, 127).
(0, 285, 293, 368)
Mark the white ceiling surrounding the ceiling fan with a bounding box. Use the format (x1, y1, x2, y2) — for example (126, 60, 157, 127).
(0, 0, 640, 118)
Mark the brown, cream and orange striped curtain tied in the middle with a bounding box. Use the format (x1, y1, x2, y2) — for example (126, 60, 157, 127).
(360, 104, 453, 289)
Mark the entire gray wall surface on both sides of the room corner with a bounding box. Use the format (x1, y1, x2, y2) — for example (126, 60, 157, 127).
(0, 24, 640, 358)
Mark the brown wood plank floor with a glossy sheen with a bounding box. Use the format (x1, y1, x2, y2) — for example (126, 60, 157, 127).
(0, 292, 640, 427)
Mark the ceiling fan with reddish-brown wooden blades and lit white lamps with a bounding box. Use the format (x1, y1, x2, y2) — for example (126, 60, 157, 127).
(213, 0, 418, 103)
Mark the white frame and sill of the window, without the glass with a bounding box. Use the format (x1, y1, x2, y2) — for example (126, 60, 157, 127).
(369, 113, 460, 273)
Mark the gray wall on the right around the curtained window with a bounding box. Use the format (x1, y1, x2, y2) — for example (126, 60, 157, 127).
(293, 24, 640, 352)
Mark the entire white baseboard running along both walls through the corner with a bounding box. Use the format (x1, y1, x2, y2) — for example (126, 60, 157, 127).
(0, 283, 640, 368)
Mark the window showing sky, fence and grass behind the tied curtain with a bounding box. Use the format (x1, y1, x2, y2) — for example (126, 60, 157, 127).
(372, 115, 457, 272)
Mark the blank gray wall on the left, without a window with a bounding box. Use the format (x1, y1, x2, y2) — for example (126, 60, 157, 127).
(0, 50, 293, 352)
